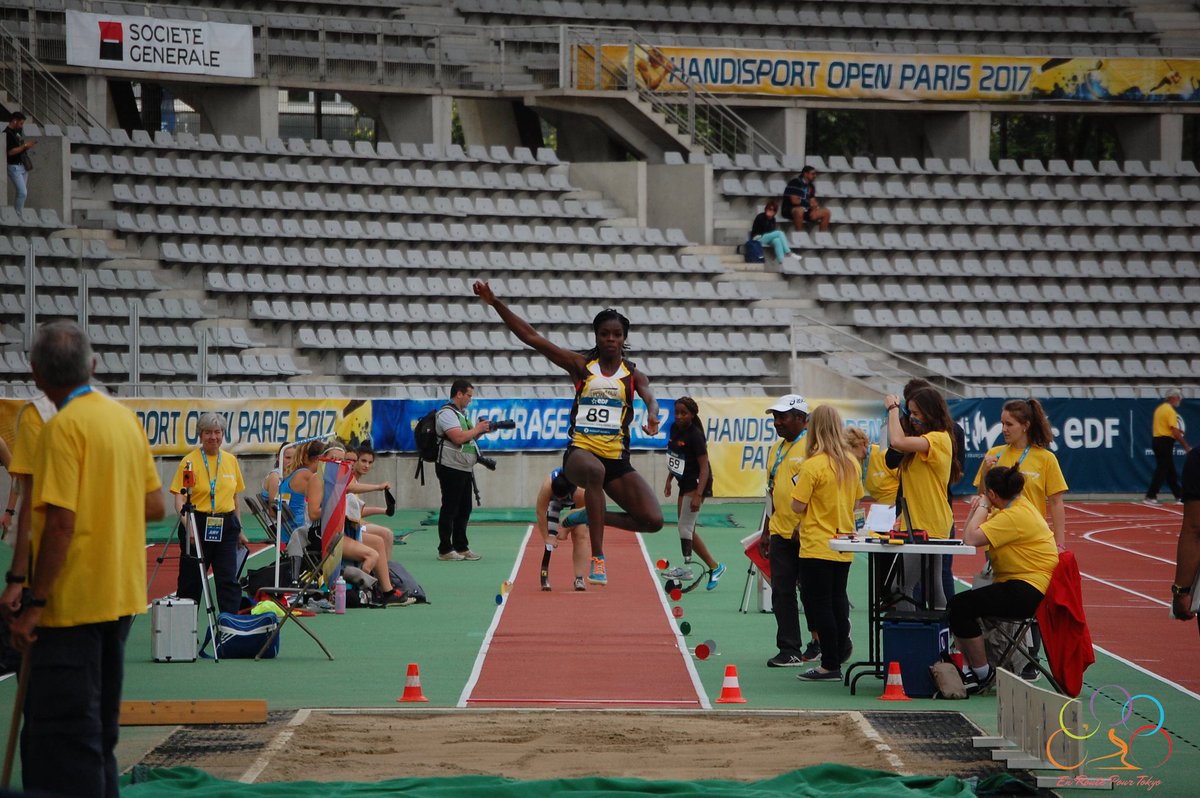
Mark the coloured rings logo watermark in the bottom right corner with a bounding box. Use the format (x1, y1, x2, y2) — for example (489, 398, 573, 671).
(1045, 684, 1175, 790)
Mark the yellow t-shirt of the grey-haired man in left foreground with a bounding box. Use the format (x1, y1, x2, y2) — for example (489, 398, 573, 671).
(32, 391, 162, 626)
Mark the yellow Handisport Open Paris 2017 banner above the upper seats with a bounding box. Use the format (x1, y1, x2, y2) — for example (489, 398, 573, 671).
(575, 44, 1200, 103)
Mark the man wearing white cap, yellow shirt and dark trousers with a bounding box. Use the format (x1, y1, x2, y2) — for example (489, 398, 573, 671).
(758, 394, 821, 667)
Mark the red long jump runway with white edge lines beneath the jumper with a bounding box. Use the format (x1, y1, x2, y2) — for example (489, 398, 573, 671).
(458, 527, 709, 709)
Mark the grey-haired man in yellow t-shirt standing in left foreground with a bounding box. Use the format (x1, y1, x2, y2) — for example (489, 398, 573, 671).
(11, 322, 163, 798)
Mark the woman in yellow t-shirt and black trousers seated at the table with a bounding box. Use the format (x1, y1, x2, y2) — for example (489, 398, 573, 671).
(949, 466, 1058, 692)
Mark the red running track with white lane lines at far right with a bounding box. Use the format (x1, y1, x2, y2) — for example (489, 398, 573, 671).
(954, 500, 1200, 694)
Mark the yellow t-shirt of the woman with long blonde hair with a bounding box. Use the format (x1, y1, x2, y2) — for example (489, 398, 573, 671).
(792, 452, 863, 563)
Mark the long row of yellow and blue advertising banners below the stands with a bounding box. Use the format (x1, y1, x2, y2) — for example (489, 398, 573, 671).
(0, 396, 1200, 497)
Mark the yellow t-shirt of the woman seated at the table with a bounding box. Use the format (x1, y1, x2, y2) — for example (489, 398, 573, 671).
(979, 496, 1058, 593)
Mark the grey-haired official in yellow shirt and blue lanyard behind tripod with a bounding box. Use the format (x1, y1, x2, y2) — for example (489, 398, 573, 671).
(170, 413, 247, 613)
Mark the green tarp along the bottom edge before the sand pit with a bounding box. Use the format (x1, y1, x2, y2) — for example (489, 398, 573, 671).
(121, 751, 974, 798)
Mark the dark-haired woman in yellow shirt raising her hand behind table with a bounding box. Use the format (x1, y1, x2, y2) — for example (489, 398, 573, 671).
(884, 388, 962, 610)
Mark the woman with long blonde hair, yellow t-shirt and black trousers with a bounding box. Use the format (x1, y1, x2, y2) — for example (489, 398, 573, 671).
(792, 404, 863, 682)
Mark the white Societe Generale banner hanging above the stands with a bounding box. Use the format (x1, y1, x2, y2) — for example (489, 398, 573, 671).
(66, 10, 254, 78)
